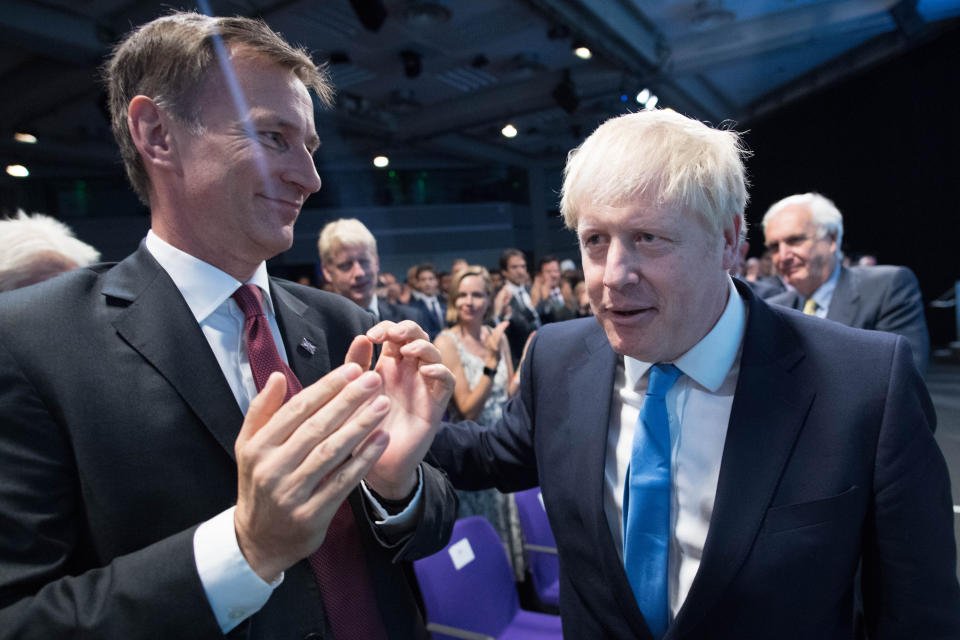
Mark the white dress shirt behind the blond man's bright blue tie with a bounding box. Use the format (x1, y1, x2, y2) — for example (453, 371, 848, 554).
(603, 279, 746, 617)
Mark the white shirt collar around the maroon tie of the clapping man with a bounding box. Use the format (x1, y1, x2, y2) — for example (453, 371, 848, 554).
(145, 229, 273, 323)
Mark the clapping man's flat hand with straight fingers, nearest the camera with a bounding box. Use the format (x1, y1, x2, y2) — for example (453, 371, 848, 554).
(234, 363, 390, 582)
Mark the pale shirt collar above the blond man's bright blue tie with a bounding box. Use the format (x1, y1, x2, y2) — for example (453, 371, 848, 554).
(623, 277, 746, 392)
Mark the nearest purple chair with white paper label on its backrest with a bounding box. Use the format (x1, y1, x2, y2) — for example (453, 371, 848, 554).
(413, 516, 563, 640)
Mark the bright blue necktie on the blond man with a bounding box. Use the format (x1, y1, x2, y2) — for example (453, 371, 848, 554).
(623, 364, 682, 638)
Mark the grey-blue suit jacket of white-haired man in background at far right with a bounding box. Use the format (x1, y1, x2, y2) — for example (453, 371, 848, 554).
(767, 265, 930, 373)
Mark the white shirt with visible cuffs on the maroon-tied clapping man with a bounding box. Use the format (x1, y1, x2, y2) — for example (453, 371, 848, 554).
(145, 230, 422, 633)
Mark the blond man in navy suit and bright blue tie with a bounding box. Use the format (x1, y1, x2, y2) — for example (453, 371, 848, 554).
(431, 111, 960, 640)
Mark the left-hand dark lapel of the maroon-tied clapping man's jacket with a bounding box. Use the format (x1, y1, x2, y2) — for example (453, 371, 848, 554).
(102, 245, 243, 457)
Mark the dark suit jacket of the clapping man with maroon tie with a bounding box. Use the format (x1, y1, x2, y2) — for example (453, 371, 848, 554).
(0, 247, 456, 639)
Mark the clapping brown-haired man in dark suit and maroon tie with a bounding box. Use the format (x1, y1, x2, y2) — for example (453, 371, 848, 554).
(0, 13, 456, 640)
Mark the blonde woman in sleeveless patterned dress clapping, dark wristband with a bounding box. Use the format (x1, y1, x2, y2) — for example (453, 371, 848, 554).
(435, 265, 523, 580)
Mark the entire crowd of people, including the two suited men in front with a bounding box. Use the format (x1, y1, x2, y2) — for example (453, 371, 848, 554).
(0, 12, 960, 640)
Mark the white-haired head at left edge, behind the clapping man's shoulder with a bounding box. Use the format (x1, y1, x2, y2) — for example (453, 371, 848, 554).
(0, 211, 100, 291)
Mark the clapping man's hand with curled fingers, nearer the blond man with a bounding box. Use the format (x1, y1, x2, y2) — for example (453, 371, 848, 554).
(346, 320, 455, 500)
